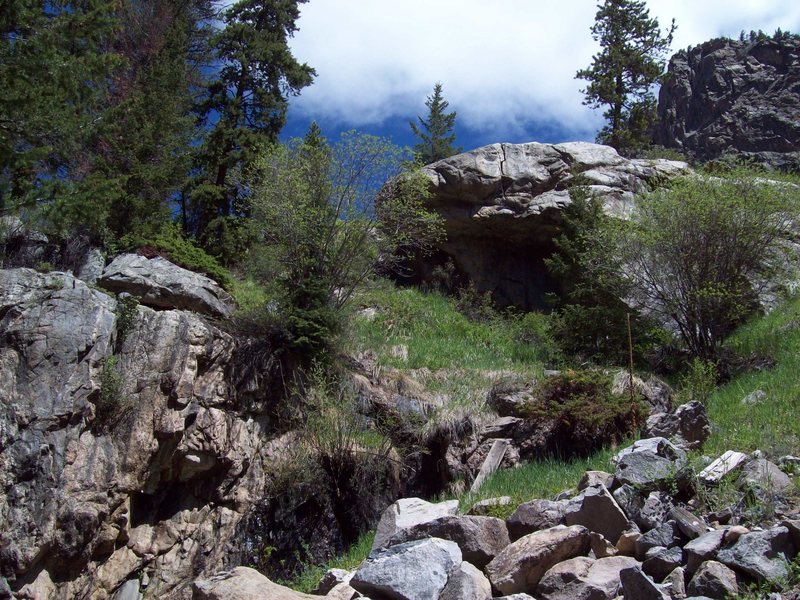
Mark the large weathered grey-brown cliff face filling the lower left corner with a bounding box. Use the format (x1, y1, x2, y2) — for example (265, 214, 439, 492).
(0, 269, 266, 598)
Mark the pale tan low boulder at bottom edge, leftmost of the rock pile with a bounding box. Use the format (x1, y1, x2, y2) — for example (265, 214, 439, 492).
(192, 567, 319, 600)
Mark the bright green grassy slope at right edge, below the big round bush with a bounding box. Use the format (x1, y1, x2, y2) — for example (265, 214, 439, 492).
(703, 298, 800, 458)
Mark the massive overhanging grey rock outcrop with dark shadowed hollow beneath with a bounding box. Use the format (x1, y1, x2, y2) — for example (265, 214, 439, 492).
(421, 142, 686, 308)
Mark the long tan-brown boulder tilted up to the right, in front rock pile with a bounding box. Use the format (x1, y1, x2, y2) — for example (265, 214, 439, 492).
(485, 525, 590, 594)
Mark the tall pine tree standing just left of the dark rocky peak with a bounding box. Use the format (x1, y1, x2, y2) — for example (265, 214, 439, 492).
(576, 0, 675, 153)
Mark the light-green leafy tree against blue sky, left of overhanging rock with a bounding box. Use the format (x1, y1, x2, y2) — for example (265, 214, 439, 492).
(251, 127, 441, 361)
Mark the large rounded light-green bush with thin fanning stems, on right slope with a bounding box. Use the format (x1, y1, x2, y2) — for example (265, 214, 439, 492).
(604, 170, 800, 360)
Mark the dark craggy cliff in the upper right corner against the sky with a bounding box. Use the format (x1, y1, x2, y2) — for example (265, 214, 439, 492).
(655, 39, 800, 168)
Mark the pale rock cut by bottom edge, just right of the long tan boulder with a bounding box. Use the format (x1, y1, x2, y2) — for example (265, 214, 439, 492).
(536, 556, 639, 600)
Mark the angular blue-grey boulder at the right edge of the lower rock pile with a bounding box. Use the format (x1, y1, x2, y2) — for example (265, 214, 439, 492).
(717, 527, 797, 581)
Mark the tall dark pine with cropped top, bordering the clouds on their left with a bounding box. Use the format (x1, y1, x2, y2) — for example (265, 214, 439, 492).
(191, 0, 315, 249)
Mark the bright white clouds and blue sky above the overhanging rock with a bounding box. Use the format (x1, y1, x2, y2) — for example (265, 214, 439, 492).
(285, 0, 800, 149)
